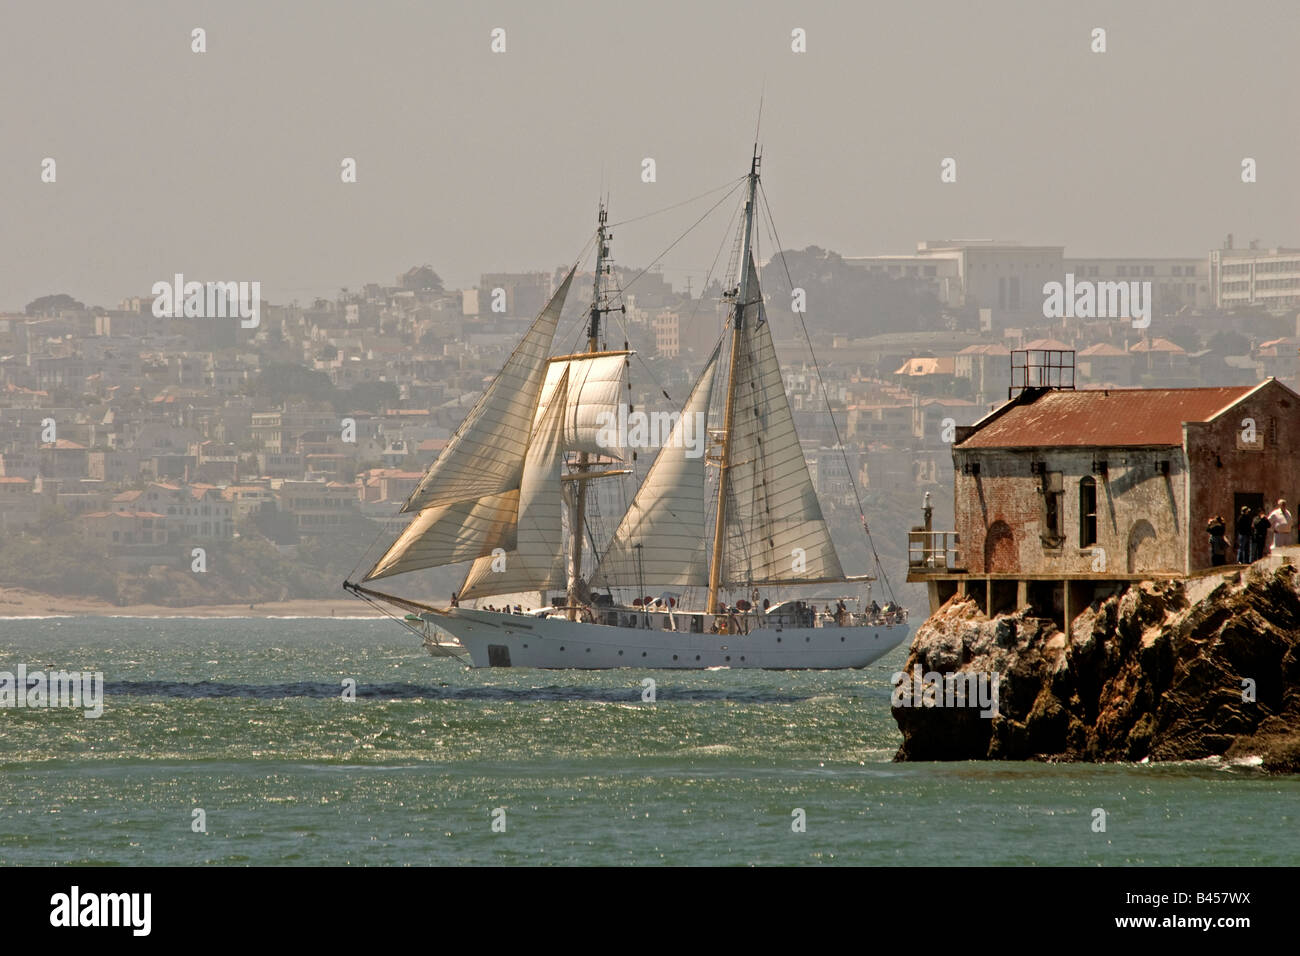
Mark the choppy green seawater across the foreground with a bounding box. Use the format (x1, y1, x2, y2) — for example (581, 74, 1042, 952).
(0, 618, 1300, 866)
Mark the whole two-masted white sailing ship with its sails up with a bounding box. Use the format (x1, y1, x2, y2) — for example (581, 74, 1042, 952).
(343, 146, 907, 670)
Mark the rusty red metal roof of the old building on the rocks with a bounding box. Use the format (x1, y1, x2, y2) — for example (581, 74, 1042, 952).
(958, 385, 1258, 449)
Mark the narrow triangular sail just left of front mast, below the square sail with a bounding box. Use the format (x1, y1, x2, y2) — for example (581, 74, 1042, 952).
(460, 373, 568, 598)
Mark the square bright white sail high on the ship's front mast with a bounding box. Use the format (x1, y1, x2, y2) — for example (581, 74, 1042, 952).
(534, 351, 632, 460)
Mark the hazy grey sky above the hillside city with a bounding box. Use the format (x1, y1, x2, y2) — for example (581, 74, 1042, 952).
(0, 0, 1300, 311)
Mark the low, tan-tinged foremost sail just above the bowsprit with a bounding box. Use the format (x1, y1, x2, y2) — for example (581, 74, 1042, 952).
(363, 489, 519, 581)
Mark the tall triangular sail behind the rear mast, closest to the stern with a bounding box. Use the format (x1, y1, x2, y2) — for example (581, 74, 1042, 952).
(722, 259, 844, 588)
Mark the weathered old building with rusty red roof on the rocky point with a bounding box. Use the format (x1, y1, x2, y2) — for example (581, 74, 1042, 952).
(909, 378, 1300, 634)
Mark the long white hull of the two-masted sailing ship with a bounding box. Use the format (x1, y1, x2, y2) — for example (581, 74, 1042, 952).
(429, 607, 909, 670)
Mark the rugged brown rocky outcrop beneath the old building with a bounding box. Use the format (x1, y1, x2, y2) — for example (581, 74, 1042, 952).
(893, 564, 1300, 773)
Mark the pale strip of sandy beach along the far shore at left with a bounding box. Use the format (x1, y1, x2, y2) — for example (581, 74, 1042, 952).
(0, 588, 382, 619)
